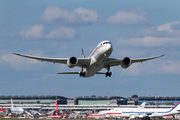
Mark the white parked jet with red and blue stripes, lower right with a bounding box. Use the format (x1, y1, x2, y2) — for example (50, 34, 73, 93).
(106, 102, 180, 119)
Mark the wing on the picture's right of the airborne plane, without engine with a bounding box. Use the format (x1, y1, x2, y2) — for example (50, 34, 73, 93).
(105, 55, 164, 66)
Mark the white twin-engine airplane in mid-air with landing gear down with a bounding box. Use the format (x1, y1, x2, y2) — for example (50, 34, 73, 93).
(13, 40, 164, 78)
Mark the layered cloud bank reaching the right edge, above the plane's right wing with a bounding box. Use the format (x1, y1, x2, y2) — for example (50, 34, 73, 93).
(116, 21, 180, 47)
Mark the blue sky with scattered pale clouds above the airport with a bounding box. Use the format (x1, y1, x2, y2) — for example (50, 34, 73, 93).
(0, 0, 180, 98)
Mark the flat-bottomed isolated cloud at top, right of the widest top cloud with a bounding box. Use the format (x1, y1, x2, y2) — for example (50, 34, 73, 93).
(106, 8, 151, 25)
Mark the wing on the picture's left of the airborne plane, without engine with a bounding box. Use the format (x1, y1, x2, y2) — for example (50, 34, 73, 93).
(13, 53, 90, 67)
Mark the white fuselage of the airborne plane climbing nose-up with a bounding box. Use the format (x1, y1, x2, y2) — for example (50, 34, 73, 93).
(83, 41, 113, 77)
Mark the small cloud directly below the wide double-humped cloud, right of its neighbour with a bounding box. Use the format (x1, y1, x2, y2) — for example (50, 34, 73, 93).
(46, 27, 76, 39)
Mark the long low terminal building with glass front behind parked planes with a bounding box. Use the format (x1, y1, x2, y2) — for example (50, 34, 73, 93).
(0, 95, 180, 110)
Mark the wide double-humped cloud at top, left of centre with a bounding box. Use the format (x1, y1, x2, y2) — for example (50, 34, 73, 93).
(40, 7, 99, 24)
